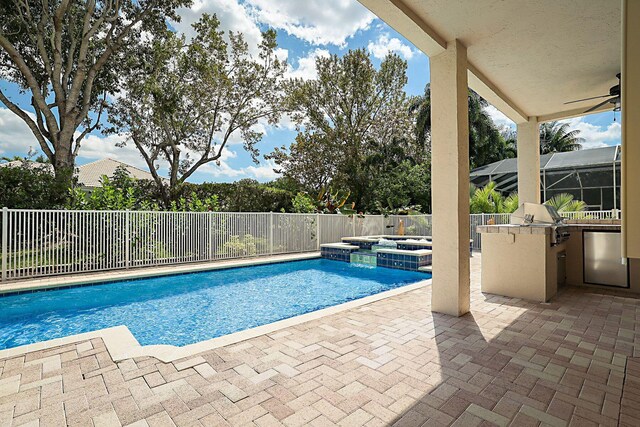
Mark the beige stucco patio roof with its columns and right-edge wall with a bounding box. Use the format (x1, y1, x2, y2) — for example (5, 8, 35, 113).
(360, 0, 640, 316)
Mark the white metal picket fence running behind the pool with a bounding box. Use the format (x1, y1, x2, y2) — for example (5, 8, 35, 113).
(1, 208, 618, 280)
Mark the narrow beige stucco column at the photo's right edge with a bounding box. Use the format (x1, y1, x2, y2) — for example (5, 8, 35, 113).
(620, 0, 640, 258)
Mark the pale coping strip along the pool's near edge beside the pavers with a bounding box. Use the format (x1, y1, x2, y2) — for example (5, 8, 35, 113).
(0, 268, 431, 363)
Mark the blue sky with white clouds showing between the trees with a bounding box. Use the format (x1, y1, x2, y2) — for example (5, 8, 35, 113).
(0, 0, 620, 182)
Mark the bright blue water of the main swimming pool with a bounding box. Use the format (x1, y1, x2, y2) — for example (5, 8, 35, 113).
(0, 259, 430, 349)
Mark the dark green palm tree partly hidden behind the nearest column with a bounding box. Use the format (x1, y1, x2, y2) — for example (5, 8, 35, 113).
(409, 84, 514, 168)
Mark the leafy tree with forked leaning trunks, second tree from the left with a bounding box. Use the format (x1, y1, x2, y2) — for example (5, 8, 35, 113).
(109, 14, 286, 203)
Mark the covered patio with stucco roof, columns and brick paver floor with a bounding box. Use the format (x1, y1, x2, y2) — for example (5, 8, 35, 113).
(0, 0, 640, 427)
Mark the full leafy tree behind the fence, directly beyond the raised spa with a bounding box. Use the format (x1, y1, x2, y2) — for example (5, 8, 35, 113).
(269, 49, 425, 209)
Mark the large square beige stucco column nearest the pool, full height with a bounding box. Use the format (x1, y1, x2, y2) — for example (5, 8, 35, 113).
(430, 40, 470, 316)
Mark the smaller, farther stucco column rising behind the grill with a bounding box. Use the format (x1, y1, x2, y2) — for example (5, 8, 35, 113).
(518, 119, 540, 203)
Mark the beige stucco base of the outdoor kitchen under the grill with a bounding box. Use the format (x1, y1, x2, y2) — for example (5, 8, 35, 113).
(481, 233, 565, 302)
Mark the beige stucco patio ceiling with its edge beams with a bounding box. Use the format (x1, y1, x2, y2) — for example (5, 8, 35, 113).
(360, 0, 621, 123)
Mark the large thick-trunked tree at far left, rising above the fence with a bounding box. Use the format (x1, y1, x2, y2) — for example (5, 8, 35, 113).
(0, 0, 189, 189)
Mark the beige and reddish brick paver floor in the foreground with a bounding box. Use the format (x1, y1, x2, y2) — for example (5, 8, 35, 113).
(0, 255, 640, 426)
